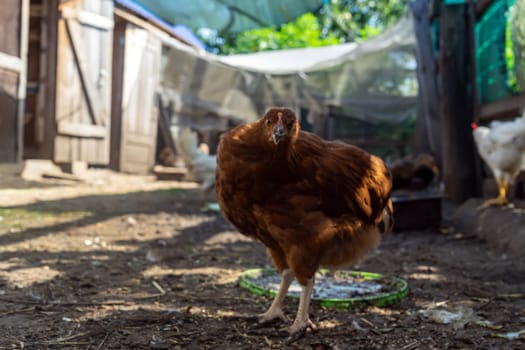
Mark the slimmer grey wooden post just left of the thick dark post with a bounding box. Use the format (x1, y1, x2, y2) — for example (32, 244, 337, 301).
(410, 0, 442, 169)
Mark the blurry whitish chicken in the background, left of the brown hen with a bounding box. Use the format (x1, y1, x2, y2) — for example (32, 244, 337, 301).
(176, 128, 217, 191)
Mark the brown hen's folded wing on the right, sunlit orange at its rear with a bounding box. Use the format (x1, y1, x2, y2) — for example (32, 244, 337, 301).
(297, 133, 392, 220)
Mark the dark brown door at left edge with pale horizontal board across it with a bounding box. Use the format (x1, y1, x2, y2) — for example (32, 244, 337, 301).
(0, 0, 29, 162)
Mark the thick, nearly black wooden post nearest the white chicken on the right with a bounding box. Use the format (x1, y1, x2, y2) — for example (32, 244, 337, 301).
(439, 2, 481, 203)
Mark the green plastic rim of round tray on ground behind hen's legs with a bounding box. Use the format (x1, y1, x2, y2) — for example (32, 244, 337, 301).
(239, 268, 408, 309)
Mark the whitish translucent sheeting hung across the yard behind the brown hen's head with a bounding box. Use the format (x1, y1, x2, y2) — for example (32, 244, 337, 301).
(162, 17, 417, 129)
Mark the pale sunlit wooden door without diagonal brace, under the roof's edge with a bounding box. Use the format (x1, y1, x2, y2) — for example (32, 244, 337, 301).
(111, 19, 162, 174)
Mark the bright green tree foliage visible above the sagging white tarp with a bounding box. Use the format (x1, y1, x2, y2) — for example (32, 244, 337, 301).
(200, 0, 409, 54)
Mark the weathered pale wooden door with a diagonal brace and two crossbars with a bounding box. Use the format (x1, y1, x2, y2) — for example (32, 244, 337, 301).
(54, 0, 113, 165)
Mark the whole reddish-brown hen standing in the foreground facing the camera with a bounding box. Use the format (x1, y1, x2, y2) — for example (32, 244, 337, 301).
(216, 108, 393, 334)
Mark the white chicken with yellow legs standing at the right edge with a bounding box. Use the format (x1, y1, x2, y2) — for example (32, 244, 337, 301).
(472, 111, 525, 207)
